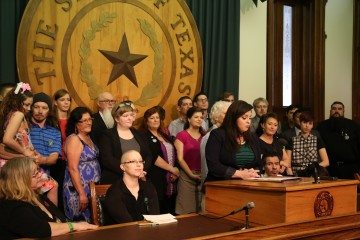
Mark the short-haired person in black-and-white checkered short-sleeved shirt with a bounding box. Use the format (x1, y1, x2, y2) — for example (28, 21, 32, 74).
(286, 111, 329, 177)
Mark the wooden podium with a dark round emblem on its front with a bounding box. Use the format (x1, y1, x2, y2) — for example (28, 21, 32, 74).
(205, 178, 359, 226)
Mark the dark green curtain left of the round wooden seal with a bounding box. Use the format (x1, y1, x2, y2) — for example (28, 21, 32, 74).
(0, 0, 27, 83)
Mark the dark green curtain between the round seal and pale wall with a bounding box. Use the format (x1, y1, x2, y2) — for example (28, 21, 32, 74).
(187, 0, 240, 103)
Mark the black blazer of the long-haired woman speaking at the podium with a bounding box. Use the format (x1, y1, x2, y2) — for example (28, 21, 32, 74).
(205, 128, 261, 180)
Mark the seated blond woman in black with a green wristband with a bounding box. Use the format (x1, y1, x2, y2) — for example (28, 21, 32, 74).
(0, 157, 97, 239)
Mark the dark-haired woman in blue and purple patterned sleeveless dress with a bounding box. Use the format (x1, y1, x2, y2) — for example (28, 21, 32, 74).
(63, 107, 101, 222)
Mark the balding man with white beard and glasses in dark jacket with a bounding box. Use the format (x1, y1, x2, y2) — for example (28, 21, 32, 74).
(91, 92, 116, 145)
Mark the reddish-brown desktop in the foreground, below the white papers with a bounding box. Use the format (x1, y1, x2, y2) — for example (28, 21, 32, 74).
(47, 214, 243, 240)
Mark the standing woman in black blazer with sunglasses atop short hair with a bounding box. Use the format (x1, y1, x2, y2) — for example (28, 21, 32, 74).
(98, 101, 153, 184)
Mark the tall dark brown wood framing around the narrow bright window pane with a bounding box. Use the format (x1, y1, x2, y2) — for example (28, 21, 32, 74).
(266, 0, 326, 122)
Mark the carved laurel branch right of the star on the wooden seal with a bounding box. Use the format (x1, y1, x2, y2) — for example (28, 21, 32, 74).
(134, 19, 164, 107)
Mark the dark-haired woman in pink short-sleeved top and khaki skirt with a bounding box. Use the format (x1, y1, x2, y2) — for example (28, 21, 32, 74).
(174, 107, 205, 214)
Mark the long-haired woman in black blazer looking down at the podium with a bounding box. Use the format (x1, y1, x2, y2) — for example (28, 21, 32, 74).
(205, 100, 261, 181)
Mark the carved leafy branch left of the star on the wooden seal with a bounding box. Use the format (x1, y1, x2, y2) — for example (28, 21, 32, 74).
(79, 12, 117, 100)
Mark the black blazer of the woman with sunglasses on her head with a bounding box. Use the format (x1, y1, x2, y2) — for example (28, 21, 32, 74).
(98, 125, 153, 184)
